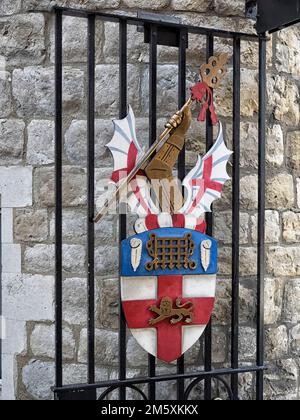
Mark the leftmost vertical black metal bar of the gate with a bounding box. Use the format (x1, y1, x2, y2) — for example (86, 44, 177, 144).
(55, 10, 63, 387)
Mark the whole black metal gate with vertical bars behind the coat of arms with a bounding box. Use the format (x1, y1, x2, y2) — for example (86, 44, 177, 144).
(53, 7, 267, 400)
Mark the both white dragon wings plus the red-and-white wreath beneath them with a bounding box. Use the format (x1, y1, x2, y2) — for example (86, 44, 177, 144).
(107, 107, 232, 225)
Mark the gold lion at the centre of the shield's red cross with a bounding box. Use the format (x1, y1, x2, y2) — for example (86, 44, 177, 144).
(149, 297, 193, 325)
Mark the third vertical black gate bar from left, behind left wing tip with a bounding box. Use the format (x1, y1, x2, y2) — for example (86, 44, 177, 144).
(119, 20, 127, 400)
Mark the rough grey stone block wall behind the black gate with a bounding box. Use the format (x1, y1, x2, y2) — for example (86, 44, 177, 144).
(0, 0, 300, 399)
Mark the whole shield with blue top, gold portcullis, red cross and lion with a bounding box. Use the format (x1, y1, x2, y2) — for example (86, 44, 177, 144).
(121, 228, 217, 362)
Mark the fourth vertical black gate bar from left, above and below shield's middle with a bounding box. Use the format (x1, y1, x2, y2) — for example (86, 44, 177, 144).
(148, 25, 157, 401)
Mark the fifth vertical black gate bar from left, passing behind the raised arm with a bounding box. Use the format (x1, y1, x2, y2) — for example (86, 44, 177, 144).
(177, 29, 188, 400)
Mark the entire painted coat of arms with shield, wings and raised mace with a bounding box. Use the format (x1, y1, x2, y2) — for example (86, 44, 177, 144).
(95, 54, 232, 362)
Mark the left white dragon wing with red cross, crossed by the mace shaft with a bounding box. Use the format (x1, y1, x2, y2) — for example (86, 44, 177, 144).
(107, 106, 158, 217)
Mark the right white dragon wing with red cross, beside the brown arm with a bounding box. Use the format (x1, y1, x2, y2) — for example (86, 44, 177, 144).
(179, 122, 233, 217)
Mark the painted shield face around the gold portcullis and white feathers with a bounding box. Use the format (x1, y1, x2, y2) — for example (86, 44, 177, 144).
(121, 229, 216, 362)
